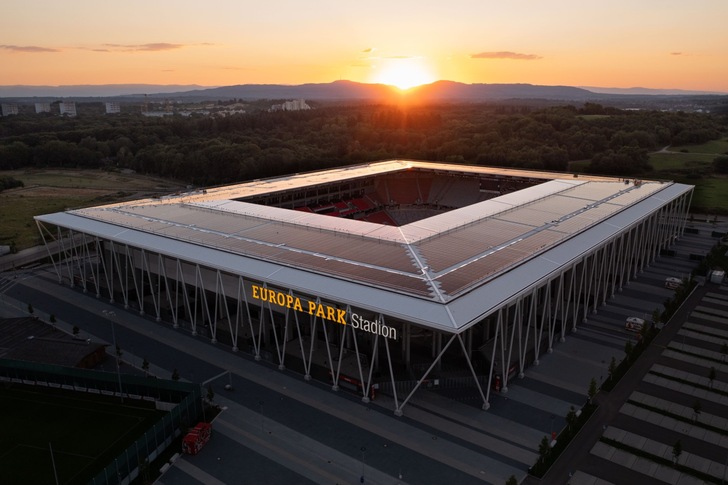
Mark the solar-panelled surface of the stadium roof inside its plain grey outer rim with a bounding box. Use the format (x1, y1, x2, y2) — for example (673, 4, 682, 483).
(68, 162, 663, 300)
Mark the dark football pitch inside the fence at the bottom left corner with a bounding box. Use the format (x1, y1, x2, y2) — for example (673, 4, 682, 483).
(0, 383, 164, 485)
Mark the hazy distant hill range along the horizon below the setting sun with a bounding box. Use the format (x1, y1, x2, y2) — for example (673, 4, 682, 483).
(0, 81, 728, 102)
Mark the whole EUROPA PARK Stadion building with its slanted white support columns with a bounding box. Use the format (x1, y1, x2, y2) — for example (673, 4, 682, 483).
(35, 160, 693, 415)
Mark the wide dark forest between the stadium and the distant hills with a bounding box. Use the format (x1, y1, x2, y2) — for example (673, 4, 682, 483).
(0, 103, 728, 186)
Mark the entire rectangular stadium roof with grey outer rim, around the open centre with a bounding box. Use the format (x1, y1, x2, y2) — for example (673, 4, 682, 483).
(36, 161, 692, 331)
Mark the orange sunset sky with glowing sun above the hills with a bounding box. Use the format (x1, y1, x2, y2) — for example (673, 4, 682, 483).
(0, 0, 728, 92)
